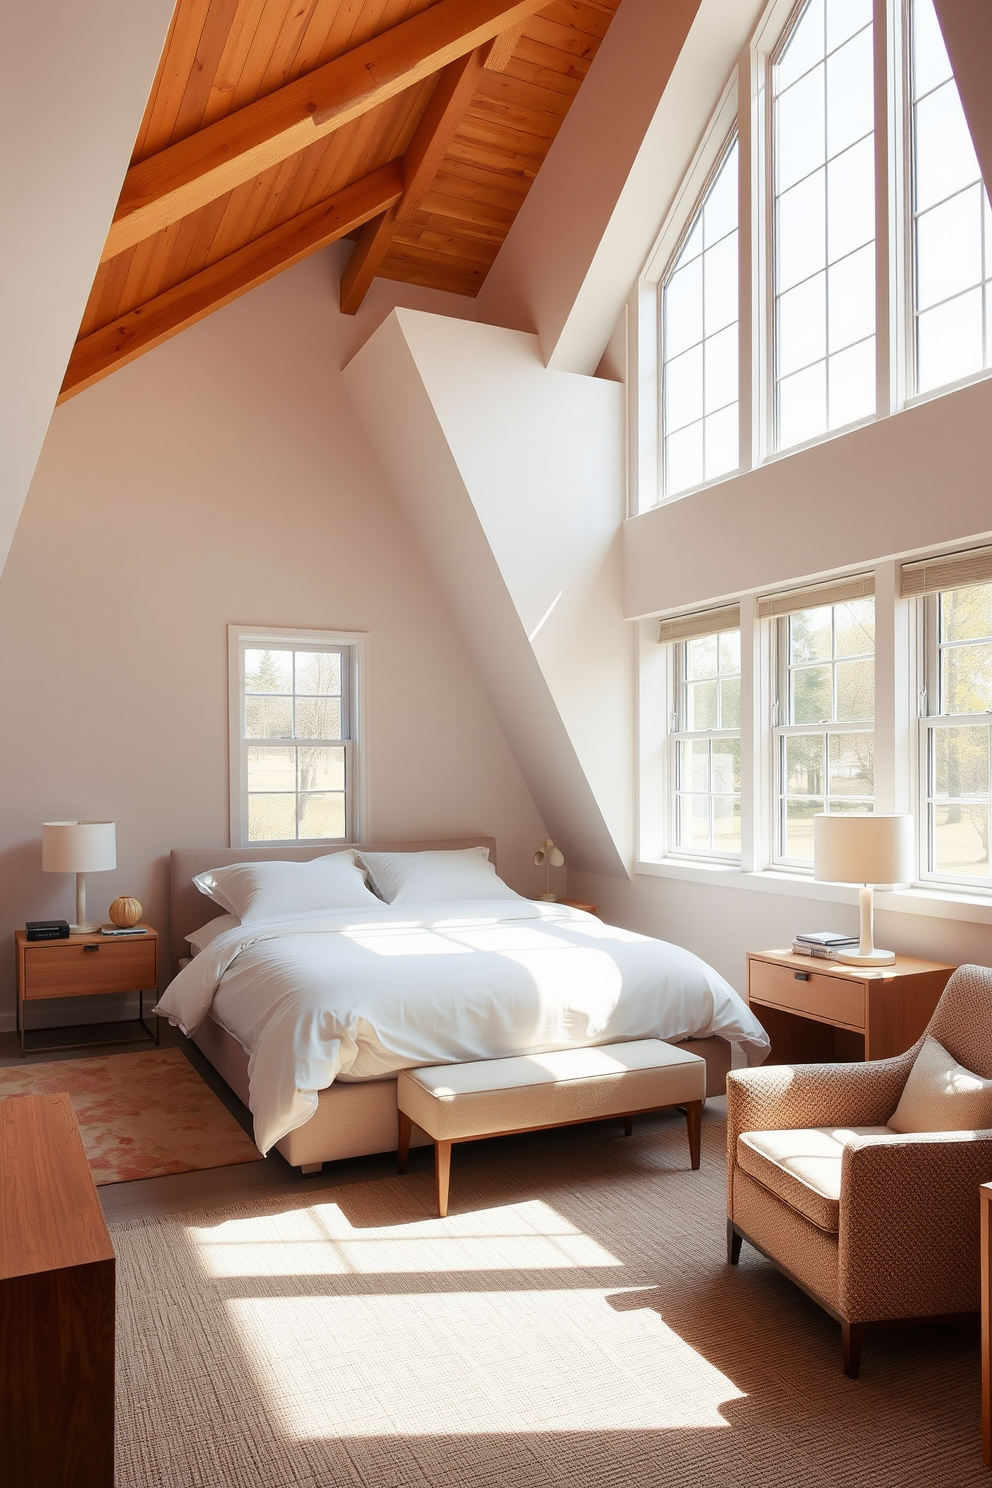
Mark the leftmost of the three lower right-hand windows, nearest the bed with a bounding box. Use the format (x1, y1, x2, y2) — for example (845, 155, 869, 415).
(660, 606, 741, 862)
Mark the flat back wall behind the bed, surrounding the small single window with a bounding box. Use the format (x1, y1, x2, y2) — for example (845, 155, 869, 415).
(0, 250, 544, 1027)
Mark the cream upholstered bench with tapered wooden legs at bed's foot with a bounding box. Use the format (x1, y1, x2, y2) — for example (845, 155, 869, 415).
(396, 1039, 706, 1219)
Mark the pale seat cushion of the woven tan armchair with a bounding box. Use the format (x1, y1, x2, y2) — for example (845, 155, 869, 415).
(736, 1126, 892, 1235)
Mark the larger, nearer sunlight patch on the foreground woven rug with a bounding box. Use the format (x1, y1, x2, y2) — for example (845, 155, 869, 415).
(228, 1287, 742, 1440)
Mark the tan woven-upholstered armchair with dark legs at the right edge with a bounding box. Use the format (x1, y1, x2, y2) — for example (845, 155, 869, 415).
(727, 966, 992, 1379)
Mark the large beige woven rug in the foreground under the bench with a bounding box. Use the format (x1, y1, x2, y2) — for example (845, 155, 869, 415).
(115, 1103, 988, 1488)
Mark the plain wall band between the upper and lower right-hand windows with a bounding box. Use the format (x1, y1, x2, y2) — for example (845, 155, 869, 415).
(625, 379, 992, 618)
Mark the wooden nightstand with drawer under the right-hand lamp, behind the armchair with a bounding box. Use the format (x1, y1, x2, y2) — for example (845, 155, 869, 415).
(748, 951, 955, 1064)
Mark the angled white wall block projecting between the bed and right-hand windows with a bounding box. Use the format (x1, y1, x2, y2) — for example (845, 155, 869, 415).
(345, 310, 632, 873)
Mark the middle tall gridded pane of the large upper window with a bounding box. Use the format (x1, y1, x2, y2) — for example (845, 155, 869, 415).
(772, 0, 876, 449)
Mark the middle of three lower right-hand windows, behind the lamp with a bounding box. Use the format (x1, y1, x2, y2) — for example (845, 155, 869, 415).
(759, 576, 875, 866)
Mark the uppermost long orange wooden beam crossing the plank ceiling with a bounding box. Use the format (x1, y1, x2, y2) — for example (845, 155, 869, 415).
(101, 0, 547, 262)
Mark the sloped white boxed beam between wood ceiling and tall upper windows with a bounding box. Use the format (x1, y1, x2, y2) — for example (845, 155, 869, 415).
(476, 0, 766, 373)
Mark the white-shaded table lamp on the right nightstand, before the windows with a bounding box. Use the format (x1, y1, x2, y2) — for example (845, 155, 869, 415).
(814, 814, 916, 966)
